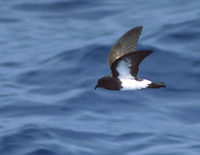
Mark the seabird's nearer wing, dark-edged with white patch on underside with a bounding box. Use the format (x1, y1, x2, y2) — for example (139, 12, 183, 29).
(111, 51, 152, 79)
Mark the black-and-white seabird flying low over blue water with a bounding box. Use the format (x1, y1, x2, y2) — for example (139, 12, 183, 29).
(95, 26, 166, 90)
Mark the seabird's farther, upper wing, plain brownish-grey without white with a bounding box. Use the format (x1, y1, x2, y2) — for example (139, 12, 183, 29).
(108, 26, 143, 67)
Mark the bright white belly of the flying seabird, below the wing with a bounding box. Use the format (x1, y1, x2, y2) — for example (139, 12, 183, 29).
(120, 78, 152, 90)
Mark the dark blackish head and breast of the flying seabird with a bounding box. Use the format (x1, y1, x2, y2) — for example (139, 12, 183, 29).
(95, 76, 121, 90)
